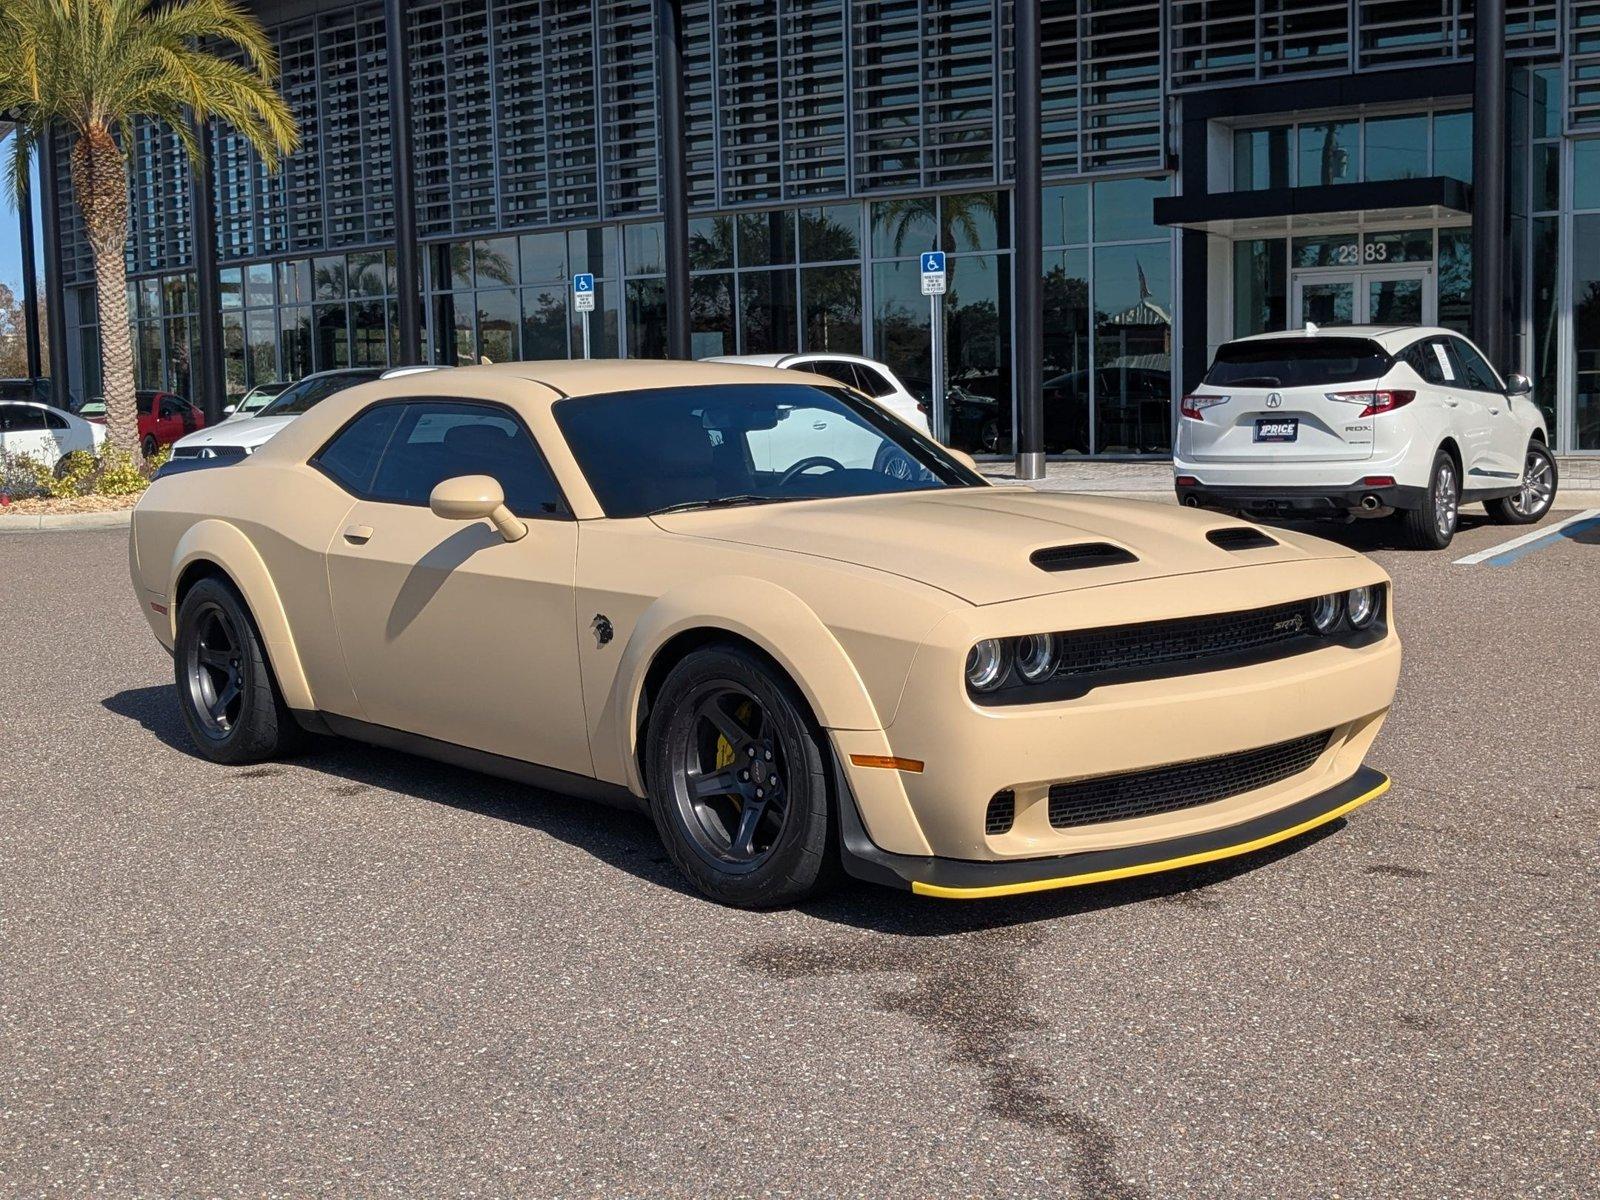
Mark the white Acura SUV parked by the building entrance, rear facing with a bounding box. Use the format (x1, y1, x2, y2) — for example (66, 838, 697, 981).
(1173, 325, 1557, 549)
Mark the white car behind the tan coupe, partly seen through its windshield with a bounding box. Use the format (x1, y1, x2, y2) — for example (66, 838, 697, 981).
(702, 352, 933, 478)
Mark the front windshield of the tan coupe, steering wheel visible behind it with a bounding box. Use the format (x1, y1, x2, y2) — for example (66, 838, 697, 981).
(554, 384, 984, 517)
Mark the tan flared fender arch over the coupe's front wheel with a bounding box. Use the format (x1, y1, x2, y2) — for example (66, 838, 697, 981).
(597, 576, 883, 795)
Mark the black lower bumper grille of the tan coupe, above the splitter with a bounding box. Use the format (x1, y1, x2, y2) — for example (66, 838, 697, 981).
(1050, 730, 1333, 829)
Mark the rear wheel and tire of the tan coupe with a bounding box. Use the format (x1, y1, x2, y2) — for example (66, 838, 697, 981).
(173, 578, 304, 763)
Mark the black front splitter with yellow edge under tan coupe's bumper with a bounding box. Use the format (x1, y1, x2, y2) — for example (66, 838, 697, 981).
(837, 766, 1389, 899)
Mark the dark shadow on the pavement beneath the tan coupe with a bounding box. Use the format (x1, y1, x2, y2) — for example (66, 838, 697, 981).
(101, 685, 1346, 938)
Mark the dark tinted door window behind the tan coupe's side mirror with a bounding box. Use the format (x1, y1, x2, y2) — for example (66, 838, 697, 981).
(370, 400, 562, 517)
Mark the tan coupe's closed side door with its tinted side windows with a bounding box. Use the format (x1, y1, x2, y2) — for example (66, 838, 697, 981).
(312, 400, 592, 774)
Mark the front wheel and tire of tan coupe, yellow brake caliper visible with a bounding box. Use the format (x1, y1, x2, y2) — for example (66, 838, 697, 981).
(645, 645, 837, 909)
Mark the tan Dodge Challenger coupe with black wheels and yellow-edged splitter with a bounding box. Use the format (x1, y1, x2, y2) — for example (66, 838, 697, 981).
(130, 362, 1400, 907)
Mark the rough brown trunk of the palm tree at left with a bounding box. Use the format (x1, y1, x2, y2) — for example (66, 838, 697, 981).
(72, 126, 139, 458)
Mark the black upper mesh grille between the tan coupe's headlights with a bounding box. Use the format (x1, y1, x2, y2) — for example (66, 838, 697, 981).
(1056, 600, 1314, 677)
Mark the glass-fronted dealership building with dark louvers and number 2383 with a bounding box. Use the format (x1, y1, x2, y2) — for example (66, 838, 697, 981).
(12, 0, 1600, 467)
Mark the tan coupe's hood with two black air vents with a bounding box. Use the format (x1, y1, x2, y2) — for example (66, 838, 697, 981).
(653, 488, 1354, 605)
